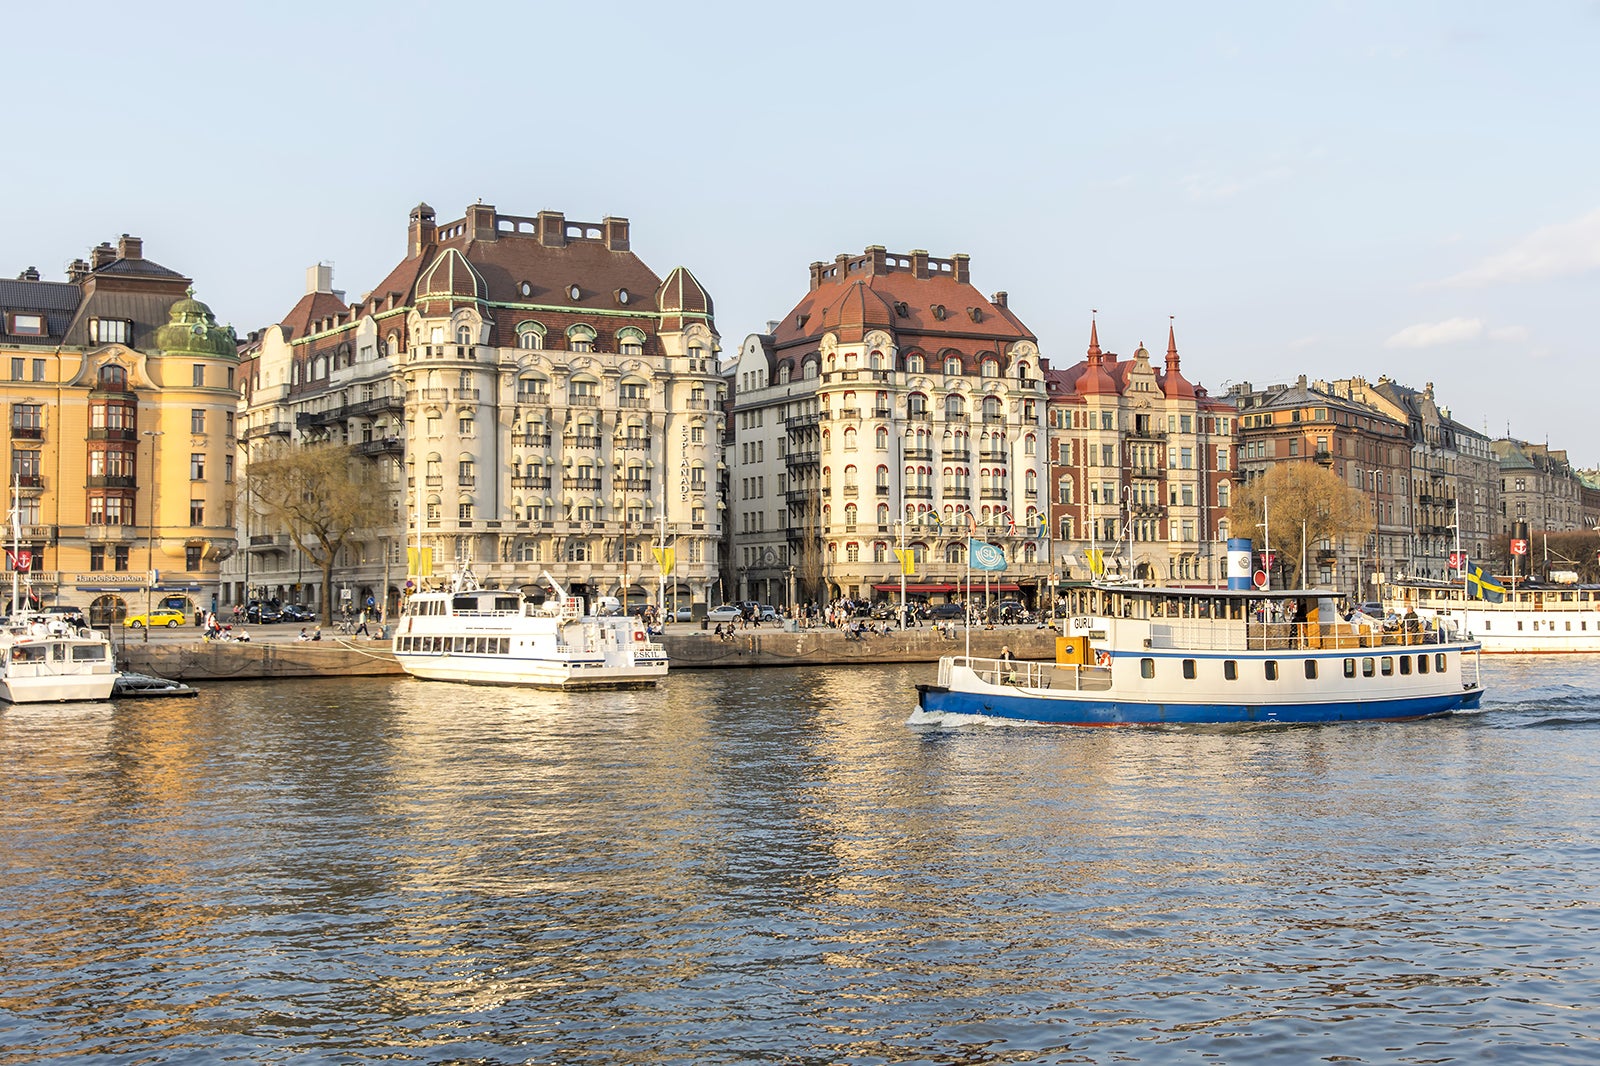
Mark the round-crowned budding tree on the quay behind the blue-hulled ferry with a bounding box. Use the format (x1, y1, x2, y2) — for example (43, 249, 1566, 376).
(1227, 463, 1373, 586)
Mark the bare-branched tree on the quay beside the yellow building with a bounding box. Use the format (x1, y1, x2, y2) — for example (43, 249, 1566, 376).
(245, 443, 389, 626)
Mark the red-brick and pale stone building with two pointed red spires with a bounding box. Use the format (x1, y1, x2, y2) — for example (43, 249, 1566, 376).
(1046, 323, 1237, 584)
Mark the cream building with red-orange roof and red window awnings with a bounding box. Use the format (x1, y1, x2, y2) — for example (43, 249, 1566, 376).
(728, 245, 1051, 603)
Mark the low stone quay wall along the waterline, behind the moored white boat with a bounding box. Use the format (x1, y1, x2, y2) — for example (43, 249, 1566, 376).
(117, 626, 1056, 683)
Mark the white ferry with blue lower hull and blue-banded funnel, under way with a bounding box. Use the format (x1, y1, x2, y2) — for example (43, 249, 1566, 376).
(918, 584, 1483, 725)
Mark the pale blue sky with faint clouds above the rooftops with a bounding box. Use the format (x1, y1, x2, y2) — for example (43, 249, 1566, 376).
(12, 0, 1600, 467)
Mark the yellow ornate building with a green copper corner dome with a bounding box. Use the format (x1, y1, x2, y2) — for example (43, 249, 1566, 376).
(0, 234, 237, 624)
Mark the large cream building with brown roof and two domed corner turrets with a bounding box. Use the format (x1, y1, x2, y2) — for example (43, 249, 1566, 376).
(230, 203, 723, 610)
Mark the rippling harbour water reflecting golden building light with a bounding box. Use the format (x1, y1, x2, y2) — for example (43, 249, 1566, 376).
(0, 659, 1600, 1064)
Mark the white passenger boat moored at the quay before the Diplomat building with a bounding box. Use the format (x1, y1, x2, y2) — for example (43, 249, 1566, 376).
(394, 573, 667, 688)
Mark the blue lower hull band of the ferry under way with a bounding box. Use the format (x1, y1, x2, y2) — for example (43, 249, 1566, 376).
(917, 685, 1483, 725)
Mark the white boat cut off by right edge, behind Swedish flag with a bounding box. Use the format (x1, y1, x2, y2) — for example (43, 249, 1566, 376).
(1384, 579, 1600, 655)
